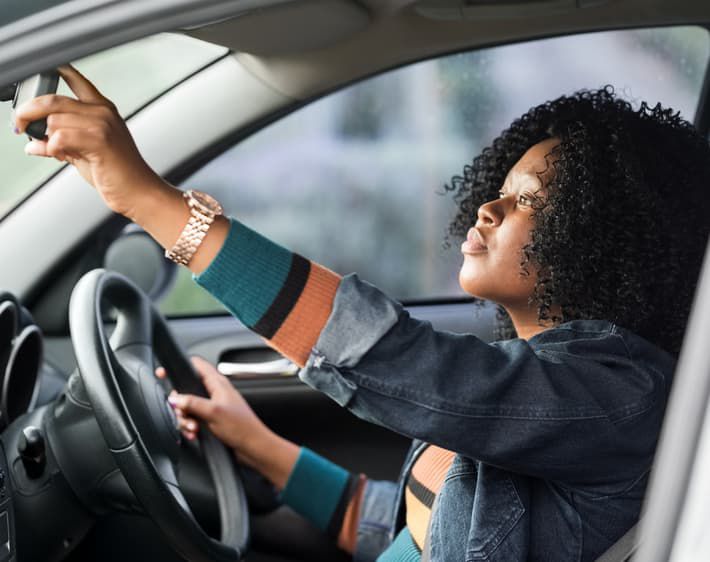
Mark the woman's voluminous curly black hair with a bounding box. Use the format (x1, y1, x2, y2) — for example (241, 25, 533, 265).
(445, 86, 710, 354)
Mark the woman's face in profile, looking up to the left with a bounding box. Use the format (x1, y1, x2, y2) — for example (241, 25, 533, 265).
(459, 138, 559, 309)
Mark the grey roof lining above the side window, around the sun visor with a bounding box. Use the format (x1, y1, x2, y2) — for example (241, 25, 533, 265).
(189, 0, 710, 100)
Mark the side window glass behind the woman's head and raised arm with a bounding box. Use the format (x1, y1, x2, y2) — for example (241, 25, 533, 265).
(161, 27, 710, 315)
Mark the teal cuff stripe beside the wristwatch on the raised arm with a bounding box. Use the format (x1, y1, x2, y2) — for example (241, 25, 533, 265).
(192, 218, 293, 327)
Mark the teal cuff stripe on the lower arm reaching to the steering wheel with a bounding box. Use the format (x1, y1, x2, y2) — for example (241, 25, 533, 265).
(281, 447, 350, 531)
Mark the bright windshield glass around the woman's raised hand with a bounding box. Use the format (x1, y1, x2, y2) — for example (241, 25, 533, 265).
(0, 33, 227, 217)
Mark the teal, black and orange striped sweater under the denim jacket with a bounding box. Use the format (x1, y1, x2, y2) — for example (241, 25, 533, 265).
(194, 219, 453, 562)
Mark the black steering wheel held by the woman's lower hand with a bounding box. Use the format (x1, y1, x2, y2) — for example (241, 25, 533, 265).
(69, 269, 249, 562)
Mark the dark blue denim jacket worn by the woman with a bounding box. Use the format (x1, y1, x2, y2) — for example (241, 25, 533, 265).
(299, 276, 675, 562)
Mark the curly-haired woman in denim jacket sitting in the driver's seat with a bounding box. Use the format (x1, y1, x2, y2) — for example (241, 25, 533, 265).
(16, 63, 710, 561)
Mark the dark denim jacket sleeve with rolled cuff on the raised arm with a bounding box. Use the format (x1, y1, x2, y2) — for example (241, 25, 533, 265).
(299, 276, 672, 486)
